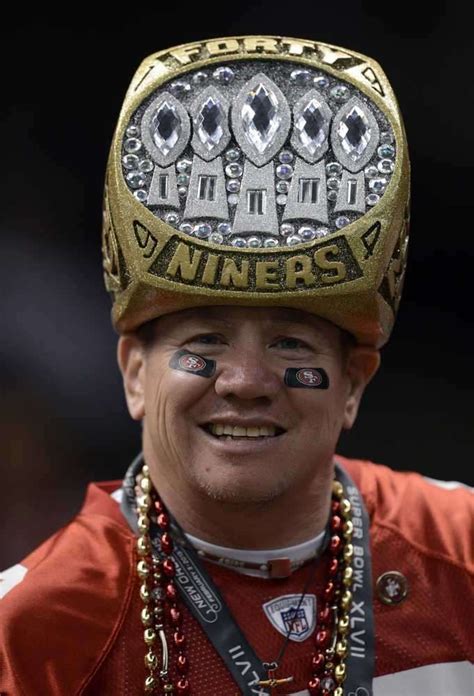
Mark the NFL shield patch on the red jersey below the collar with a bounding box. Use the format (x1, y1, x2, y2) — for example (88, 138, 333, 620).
(263, 594, 316, 642)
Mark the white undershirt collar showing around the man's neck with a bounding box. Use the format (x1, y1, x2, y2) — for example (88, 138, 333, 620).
(186, 530, 324, 578)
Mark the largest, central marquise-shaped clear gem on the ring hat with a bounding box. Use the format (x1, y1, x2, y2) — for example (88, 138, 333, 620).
(241, 83, 281, 154)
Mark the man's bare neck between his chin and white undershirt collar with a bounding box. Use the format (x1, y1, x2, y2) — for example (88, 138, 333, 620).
(145, 453, 334, 550)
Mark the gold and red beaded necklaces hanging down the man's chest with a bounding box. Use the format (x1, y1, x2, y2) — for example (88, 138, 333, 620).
(136, 464, 354, 696)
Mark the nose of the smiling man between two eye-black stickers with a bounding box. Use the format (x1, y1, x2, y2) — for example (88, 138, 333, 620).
(215, 350, 283, 399)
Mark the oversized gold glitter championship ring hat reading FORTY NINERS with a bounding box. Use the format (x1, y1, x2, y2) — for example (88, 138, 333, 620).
(103, 36, 409, 347)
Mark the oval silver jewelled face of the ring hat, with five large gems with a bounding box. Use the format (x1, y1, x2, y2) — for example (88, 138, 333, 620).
(122, 60, 396, 248)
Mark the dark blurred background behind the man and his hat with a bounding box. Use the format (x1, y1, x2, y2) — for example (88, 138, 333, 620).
(0, 0, 474, 567)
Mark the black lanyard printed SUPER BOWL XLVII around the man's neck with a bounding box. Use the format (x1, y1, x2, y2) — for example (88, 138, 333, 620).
(121, 454, 374, 696)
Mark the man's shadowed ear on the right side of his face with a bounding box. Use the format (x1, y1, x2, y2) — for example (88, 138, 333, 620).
(342, 346, 380, 430)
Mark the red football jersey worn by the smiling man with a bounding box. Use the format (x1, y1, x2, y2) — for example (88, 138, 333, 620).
(0, 458, 474, 696)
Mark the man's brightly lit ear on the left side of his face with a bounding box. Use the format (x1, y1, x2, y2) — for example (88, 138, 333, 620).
(117, 334, 145, 420)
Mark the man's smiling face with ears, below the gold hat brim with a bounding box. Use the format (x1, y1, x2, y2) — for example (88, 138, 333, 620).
(119, 306, 374, 503)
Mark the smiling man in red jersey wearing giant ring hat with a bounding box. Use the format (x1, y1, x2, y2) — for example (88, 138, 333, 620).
(0, 37, 473, 696)
